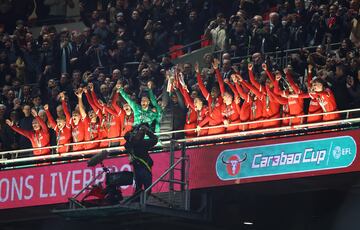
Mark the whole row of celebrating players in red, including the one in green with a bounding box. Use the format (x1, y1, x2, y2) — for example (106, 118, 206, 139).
(1, 55, 348, 155)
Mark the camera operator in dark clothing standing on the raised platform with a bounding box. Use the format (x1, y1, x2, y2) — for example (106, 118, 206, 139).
(124, 124, 158, 196)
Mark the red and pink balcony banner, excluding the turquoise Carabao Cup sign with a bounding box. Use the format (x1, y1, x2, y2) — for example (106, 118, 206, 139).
(0, 130, 360, 209)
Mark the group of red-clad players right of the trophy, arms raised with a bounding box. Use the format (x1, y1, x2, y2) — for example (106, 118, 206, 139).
(176, 59, 340, 137)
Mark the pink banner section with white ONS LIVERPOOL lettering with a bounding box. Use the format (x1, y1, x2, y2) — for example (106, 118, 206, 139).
(0, 153, 170, 209)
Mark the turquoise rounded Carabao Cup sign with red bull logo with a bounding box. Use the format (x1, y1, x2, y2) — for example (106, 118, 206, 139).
(216, 136, 356, 180)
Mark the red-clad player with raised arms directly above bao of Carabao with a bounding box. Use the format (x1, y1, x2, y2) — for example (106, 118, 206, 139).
(265, 66, 304, 125)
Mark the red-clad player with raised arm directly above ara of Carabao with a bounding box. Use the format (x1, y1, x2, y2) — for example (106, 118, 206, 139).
(248, 63, 281, 128)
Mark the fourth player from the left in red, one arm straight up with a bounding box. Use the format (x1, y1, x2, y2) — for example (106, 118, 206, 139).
(75, 88, 100, 149)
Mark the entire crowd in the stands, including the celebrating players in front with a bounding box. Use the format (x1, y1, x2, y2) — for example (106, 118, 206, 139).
(0, 0, 360, 155)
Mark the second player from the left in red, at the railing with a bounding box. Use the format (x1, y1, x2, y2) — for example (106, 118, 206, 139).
(44, 101, 71, 154)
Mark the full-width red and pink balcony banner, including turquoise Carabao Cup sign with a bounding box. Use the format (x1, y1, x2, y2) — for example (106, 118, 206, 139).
(0, 130, 360, 209)
